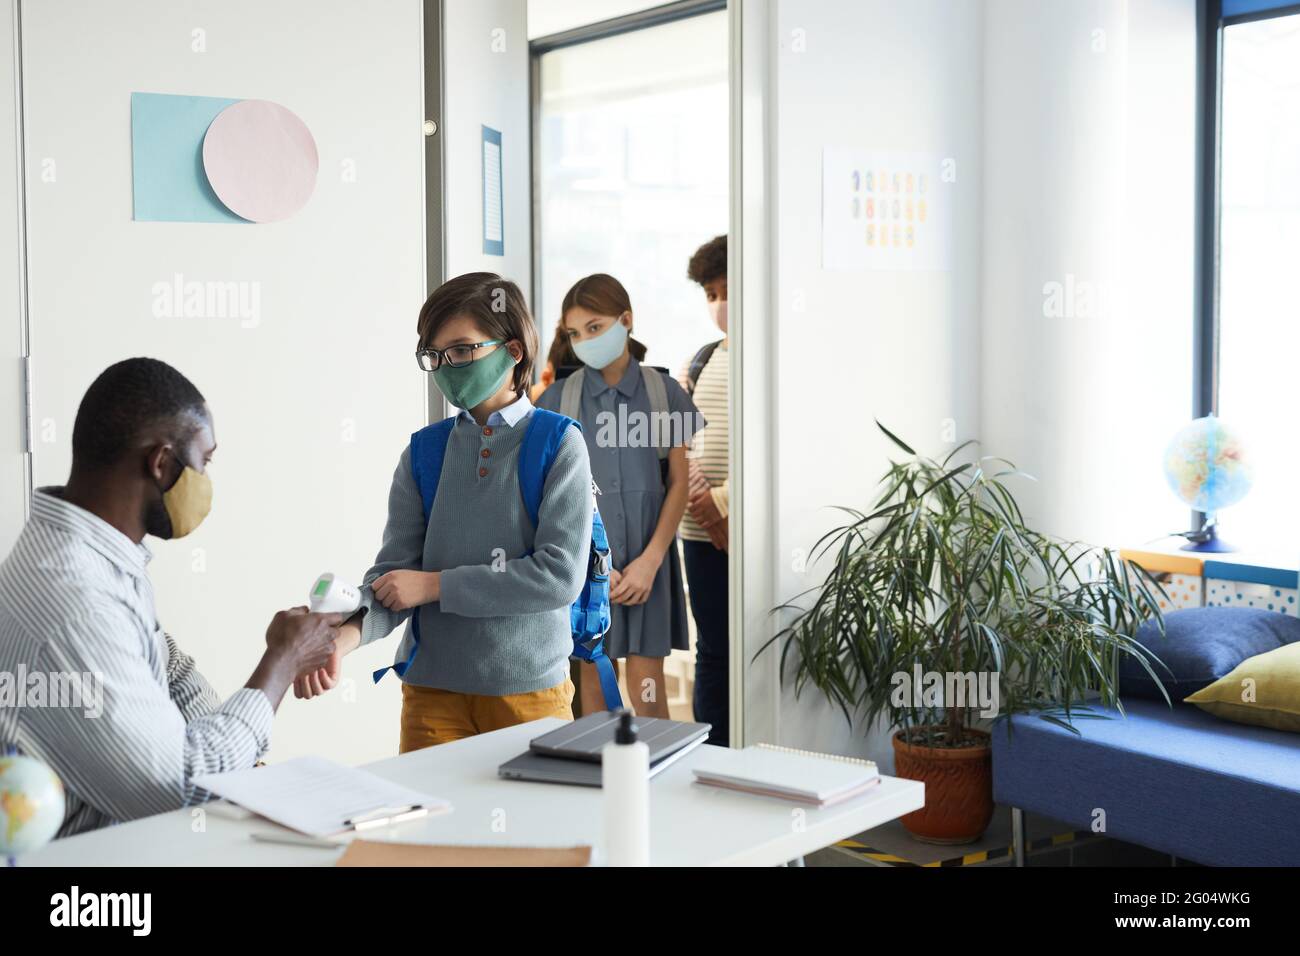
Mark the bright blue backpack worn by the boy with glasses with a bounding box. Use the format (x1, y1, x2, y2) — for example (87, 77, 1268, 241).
(374, 408, 623, 710)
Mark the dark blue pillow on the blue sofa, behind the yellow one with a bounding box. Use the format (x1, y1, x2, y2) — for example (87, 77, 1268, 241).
(1119, 607, 1300, 702)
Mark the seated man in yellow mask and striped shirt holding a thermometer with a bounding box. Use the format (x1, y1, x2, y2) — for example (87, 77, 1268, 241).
(0, 359, 341, 836)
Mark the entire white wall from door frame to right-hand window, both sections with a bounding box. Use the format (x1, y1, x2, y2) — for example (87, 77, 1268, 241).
(741, 0, 1195, 767)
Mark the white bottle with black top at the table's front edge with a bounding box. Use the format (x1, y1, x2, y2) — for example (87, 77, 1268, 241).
(601, 709, 650, 866)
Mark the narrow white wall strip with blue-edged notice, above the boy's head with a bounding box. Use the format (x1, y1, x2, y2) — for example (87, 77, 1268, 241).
(439, 0, 533, 291)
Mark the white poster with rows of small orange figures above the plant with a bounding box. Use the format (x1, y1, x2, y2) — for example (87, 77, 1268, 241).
(822, 146, 956, 272)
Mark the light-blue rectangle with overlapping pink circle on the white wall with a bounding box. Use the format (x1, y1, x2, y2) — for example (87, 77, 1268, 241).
(131, 92, 319, 222)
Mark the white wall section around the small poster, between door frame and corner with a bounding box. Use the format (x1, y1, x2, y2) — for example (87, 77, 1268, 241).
(746, 0, 982, 760)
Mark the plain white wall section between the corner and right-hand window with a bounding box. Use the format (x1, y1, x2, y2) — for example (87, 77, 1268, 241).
(982, 0, 1196, 546)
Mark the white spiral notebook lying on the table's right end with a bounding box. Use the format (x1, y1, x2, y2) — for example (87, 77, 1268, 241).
(692, 744, 880, 806)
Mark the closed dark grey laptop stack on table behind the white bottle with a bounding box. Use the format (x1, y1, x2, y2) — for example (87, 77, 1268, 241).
(497, 710, 711, 787)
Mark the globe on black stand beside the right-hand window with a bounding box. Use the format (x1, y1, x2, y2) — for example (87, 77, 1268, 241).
(1165, 415, 1255, 551)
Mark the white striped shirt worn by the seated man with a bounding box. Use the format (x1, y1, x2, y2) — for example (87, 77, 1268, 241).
(0, 489, 273, 836)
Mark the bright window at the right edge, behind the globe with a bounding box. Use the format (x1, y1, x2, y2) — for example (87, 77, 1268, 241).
(1206, 0, 1300, 550)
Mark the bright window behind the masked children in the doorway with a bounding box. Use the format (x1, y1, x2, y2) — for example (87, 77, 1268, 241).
(534, 10, 729, 375)
